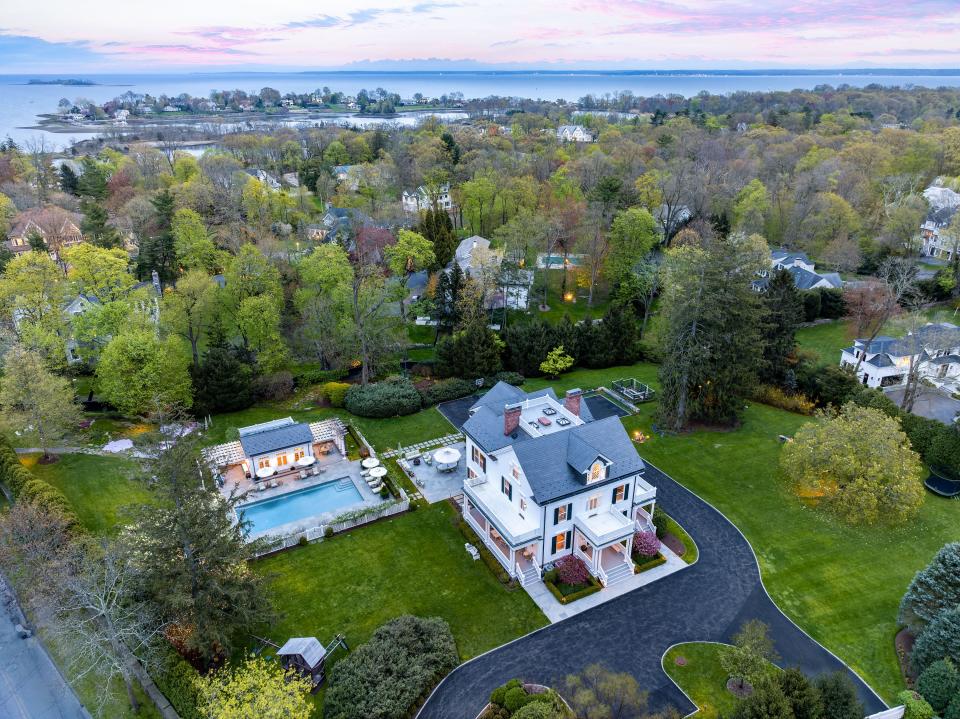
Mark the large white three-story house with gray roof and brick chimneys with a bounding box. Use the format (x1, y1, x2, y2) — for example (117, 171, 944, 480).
(462, 382, 657, 586)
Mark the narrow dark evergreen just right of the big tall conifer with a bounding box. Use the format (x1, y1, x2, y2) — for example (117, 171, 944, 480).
(760, 270, 804, 385)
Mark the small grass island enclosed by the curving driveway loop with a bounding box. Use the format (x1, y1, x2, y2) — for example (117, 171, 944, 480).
(663, 642, 773, 719)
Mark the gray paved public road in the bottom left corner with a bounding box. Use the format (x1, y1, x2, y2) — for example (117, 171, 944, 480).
(0, 592, 90, 719)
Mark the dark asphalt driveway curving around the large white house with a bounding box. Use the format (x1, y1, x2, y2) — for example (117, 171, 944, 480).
(418, 465, 885, 719)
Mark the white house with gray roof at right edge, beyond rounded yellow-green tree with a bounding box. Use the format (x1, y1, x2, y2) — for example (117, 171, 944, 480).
(840, 322, 960, 387)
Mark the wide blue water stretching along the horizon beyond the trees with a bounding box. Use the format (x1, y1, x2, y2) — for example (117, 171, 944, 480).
(0, 70, 960, 147)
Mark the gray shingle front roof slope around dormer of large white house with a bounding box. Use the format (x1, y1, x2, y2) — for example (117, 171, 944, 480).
(513, 417, 644, 505)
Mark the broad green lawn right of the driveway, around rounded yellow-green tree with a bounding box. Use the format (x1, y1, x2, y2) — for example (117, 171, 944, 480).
(624, 403, 960, 701)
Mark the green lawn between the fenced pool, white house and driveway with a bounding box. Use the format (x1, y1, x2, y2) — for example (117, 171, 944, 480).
(254, 502, 547, 708)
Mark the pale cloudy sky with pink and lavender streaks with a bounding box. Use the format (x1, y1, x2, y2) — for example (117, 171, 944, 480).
(0, 0, 960, 74)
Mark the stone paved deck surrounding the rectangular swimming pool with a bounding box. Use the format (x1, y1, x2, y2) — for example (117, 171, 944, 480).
(220, 451, 384, 538)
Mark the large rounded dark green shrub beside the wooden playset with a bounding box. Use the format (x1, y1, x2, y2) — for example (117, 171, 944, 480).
(323, 615, 459, 719)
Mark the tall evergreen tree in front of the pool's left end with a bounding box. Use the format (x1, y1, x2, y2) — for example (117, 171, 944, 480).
(124, 436, 271, 666)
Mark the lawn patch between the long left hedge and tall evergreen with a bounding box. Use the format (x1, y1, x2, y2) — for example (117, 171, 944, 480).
(21, 454, 152, 534)
